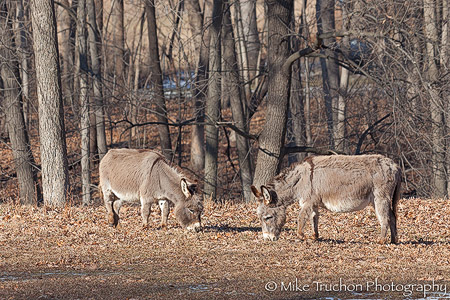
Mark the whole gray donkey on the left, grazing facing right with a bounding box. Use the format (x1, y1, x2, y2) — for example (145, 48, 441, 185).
(99, 149, 203, 231)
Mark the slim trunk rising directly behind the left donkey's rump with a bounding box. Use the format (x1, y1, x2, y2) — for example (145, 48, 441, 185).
(87, 0, 107, 160)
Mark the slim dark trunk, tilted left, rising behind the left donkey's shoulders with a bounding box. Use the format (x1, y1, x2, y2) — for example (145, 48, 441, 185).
(145, 0, 173, 161)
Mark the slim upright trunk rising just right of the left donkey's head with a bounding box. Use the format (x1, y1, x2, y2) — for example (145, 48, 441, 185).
(203, 0, 223, 199)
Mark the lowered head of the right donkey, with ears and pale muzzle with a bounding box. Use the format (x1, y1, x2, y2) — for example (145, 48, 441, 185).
(251, 185, 286, 241)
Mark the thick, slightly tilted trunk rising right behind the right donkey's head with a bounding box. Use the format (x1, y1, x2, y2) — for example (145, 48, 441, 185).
(253, 0, 293, 187)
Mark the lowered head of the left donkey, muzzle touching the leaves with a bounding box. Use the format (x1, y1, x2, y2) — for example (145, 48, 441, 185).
(174, 178, 203, 232)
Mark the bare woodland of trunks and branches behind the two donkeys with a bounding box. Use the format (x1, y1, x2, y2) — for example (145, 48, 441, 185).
(0, 0, 450, 205)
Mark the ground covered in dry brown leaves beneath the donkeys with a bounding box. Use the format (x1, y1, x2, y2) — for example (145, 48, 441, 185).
(0, 199, 450, 299)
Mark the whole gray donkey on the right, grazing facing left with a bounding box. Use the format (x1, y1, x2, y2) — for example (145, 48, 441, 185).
(251, 155, 401, 243)
